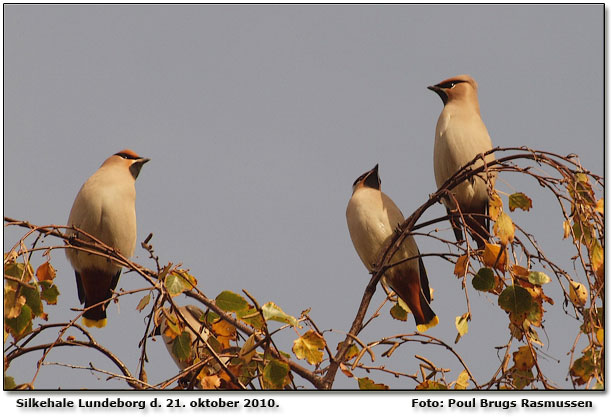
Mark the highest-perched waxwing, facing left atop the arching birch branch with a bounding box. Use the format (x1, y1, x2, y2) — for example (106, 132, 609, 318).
(427, 75, 497, 248)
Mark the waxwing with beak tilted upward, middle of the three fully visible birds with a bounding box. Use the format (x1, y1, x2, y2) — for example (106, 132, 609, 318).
(346, 165, 438, 332)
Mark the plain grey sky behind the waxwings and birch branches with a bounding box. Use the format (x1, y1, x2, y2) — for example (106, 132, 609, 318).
(4, 5, 604, 389)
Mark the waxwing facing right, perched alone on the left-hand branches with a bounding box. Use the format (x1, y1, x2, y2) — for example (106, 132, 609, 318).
(66, 149, 149, 327)
